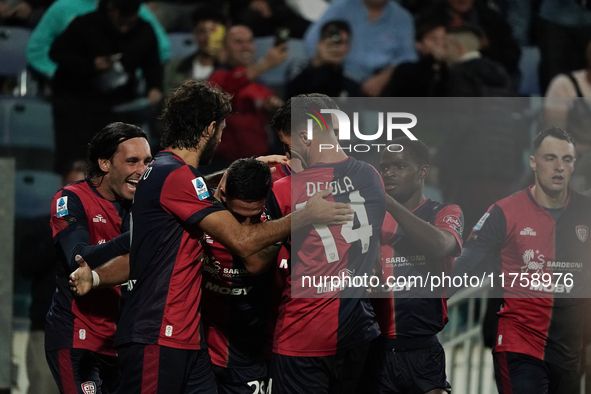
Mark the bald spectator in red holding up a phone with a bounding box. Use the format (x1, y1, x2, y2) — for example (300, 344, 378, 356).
(209, 25, 287, 170)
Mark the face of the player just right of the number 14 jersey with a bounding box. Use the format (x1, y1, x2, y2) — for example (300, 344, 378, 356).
(380, 149, 429, 204)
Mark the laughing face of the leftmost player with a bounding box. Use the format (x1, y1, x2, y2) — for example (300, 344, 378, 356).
(98, 137, 152, 200)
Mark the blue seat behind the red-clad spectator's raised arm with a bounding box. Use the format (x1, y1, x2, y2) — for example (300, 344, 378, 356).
(254, 37, 307, 87)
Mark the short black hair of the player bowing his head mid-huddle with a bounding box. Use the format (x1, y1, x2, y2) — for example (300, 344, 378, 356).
(226, 158, 273, 202)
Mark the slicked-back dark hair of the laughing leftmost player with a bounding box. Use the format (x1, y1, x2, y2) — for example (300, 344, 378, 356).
(86, 122, 148, 180)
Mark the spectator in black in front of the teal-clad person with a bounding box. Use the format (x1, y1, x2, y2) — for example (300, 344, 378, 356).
(50, 0, 163, 174)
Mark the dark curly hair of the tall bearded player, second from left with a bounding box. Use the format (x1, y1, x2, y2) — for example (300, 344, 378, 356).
(160, 79, 232, 150)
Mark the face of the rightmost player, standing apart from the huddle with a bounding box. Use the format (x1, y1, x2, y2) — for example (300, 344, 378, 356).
(530, 136, 575, 197)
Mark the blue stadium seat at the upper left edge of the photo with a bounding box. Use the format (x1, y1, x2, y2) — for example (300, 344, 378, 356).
(0, 27, 31, 76)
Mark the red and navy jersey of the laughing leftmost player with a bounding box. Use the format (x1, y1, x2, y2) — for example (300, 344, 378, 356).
(45, 180, 131, 355)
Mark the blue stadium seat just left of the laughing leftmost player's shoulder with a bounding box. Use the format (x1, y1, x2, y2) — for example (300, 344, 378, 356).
(15, 170, 61, 219)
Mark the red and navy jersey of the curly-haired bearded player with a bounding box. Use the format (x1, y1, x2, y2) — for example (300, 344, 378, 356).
(115, 151, 225, 350)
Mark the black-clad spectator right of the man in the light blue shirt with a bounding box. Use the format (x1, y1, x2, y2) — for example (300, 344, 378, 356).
(383, 20, 447, 97)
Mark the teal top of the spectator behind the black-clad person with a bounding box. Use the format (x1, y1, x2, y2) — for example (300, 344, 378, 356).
(27, 0, 170, 80)
